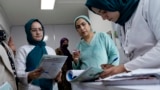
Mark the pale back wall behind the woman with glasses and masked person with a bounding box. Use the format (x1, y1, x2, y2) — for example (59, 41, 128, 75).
(11, 25, 80, 51)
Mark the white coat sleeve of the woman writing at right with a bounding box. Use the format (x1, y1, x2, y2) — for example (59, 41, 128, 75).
(124, 0, 160, 71)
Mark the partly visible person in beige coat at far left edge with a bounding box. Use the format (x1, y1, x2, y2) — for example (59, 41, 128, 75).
(0, 30, 18, 90)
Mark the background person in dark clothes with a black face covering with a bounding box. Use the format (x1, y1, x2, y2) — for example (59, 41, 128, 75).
(56, 37, 73, 90)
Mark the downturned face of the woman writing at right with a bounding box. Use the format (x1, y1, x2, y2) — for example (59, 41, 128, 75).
(92, 7, 120, 22)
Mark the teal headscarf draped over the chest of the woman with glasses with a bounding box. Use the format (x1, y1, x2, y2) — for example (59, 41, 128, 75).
(25, 19, 47, 71)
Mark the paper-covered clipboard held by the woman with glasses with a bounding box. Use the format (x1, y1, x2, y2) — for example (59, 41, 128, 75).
(39, 55, 67, 79)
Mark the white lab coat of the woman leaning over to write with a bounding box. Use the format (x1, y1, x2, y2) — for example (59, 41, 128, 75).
(117, 0, 160, 71)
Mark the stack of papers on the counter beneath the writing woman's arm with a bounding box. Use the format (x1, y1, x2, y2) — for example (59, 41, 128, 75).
(100, 69, 160, 86)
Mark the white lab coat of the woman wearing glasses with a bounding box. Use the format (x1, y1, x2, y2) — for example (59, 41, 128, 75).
(15, 45, 57, 90)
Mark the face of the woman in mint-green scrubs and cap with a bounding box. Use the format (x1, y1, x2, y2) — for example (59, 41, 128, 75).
(75, 18, 91, 38)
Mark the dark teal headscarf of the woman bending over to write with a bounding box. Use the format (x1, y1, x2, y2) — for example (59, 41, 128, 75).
(86, 0, 139, 25)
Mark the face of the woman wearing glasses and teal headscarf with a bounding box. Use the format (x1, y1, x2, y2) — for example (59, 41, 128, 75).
(31, 22, 43, 41)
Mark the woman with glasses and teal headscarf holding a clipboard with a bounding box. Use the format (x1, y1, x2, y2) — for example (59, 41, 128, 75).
(15, 19, 56, 90)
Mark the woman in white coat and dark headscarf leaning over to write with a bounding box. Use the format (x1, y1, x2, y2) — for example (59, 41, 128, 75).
(86, 0, 160, 78)
